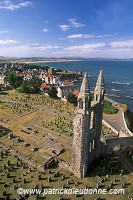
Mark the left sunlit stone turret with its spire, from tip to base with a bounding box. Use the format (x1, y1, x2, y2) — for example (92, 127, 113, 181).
(72, 73, 91, 178)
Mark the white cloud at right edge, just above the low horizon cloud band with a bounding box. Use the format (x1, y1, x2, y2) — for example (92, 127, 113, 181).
(109, 39, 133, 48)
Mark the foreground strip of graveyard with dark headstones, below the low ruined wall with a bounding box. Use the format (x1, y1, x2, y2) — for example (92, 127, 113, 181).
(0, 147, 133, 200)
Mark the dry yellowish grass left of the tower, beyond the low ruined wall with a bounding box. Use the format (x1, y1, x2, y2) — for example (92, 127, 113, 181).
(0, 90, 74, 164)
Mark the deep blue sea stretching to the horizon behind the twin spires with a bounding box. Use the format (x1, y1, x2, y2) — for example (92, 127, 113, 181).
(33, 60, 133, 111)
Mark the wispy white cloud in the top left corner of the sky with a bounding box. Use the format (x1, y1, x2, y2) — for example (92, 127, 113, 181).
(0, 0, 31, 10)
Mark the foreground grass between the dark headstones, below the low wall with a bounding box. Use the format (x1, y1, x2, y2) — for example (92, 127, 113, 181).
(0, 147, 133, 200)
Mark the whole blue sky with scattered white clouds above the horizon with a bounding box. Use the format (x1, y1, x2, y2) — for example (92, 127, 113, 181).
(0, 0, 133, 59)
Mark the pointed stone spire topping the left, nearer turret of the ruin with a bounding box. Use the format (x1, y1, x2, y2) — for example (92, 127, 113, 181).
(80, 73, 90, 95)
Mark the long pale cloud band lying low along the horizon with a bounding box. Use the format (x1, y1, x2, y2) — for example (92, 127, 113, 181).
(0, 40, 133, 58)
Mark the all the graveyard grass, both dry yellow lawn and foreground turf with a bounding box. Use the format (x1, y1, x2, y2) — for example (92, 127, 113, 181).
(0, 90, 133, 200)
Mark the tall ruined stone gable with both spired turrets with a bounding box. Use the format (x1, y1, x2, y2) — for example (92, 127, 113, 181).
(72, 71, 104, 178)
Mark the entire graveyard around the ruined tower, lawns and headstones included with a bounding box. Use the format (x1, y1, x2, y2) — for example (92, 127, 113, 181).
(0, 90, 133, 200)
